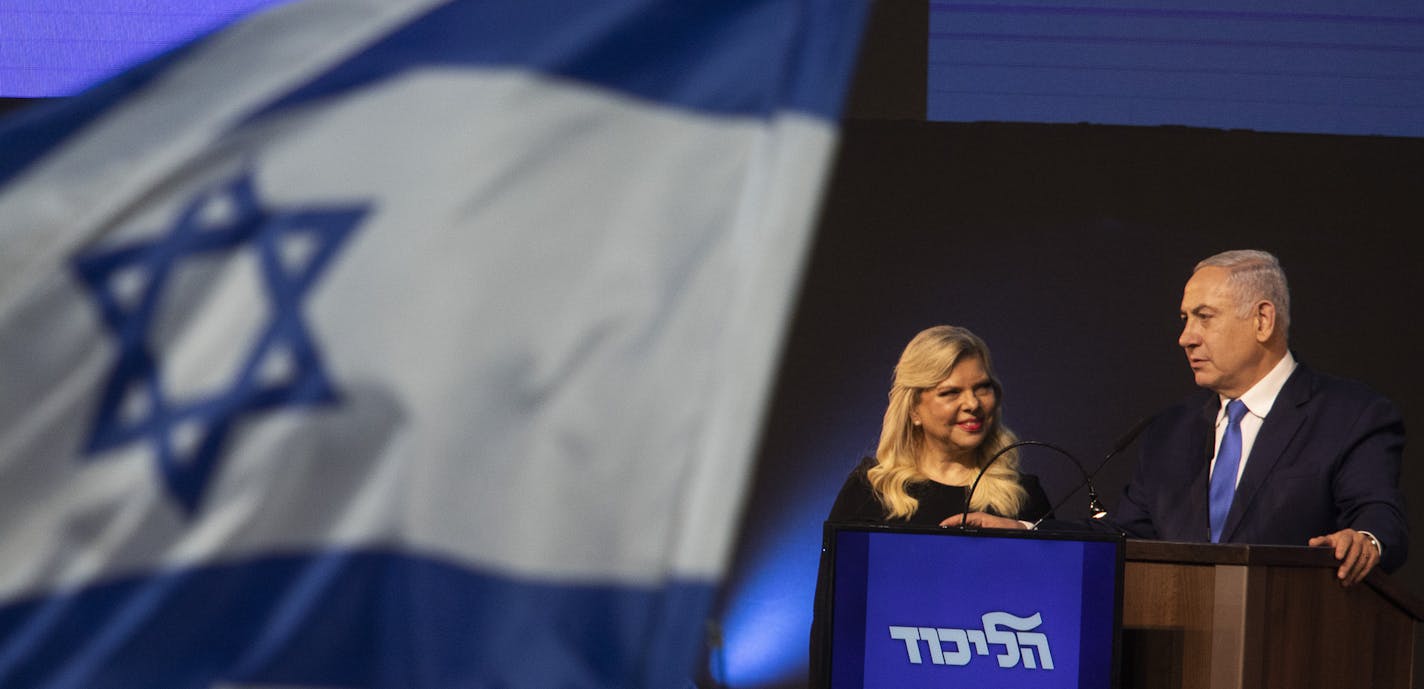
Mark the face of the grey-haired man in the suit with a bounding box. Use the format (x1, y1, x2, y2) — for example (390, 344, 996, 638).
(1176, 266, 1269, 399)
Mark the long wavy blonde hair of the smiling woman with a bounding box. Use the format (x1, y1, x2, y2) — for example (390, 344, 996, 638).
(867, 326, 1028, 518)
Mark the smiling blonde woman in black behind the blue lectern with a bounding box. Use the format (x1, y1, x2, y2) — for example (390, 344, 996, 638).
(830, 326, 1049, 528)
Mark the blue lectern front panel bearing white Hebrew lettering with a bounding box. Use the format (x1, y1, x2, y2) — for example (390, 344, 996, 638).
(822, 524, 1125, 689)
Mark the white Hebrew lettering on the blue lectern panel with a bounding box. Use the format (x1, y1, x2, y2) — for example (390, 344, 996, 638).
(890, 612, 1054, 670)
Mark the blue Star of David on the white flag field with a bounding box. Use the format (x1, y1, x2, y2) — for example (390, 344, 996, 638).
(73, 174, 369, 515)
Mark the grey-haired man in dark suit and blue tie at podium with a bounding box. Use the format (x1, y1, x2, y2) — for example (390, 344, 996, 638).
(1114, 251, 1408, 585)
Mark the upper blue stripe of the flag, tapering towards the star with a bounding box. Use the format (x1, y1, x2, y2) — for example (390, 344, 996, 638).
(249, 0, 866, 120)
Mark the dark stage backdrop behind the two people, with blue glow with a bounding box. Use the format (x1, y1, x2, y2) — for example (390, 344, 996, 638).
(711, 1, 1424, 688)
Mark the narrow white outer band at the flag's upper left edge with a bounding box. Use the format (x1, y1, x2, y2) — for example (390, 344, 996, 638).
(0, 0, 440, 317)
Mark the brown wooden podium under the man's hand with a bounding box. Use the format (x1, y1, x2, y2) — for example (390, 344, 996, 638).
(1121, 541, 1424, 689)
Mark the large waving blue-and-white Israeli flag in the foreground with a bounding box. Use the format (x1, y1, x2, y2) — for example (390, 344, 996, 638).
(0, 0, 864, 689)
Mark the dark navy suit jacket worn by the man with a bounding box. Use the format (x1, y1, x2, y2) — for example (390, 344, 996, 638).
(1112, 364, 1408, 571)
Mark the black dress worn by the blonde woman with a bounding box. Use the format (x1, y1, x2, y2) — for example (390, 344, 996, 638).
(810, 457, 1052, 689)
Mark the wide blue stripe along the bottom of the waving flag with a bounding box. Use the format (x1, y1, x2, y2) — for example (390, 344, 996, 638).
(0, 551, 713, 689)
